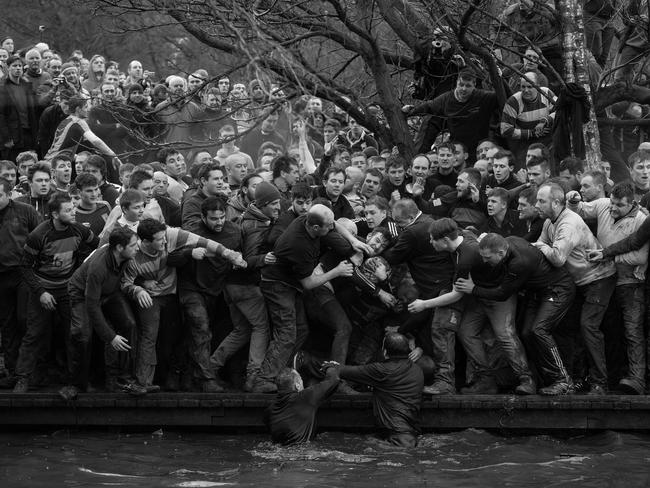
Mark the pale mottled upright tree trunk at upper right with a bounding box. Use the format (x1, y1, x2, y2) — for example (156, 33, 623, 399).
(555, 0, 602, 170)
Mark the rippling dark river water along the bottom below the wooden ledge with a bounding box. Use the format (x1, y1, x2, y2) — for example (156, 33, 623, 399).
(0, 429, 650, 488)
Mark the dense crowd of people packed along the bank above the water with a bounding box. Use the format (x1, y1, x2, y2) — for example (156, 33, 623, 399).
(0, 2, 650, 446)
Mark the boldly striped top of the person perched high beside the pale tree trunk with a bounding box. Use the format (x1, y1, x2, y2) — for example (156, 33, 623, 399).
(501, 87, 557, 139)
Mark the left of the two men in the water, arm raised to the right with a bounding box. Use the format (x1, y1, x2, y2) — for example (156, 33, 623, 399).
(264, 368, 339, 446)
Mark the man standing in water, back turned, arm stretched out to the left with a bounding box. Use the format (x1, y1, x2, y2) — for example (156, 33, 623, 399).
(323, 332, 424, 447)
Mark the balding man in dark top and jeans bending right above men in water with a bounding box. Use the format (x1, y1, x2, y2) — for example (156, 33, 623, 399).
(253, 205, 353, 393)
